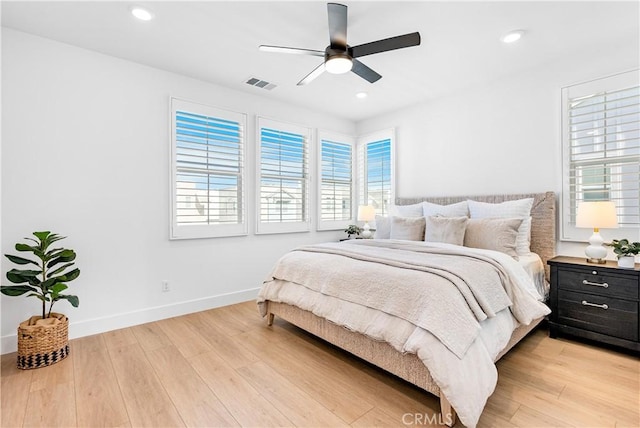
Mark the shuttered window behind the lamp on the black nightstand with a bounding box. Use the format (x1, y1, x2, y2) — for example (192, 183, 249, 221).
(562, 71, 640, 240)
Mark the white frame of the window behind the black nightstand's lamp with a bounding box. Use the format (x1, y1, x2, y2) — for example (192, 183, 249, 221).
(559, 70, 640, 242)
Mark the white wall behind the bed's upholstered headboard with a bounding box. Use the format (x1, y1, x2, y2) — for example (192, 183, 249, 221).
(357, 41, 640, 259)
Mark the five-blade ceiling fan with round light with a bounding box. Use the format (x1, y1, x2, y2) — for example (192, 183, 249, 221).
(259, 3, 420, 86)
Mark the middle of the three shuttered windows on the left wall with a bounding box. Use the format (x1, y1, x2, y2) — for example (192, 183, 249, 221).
(256, 118, 310, 233)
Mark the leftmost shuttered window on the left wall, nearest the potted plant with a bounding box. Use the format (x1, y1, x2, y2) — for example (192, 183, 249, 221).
(170, 98, 247, 239)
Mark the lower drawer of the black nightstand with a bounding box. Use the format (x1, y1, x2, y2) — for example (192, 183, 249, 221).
(556, 290, 638, 341)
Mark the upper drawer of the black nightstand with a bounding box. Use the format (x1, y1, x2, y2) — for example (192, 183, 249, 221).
(558, 267, 640, 299)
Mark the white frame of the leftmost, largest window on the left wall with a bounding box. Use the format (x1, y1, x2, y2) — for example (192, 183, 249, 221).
(169, 97, 248, 240)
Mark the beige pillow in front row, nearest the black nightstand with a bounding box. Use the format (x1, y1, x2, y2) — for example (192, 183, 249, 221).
(464, 218, 522, 260)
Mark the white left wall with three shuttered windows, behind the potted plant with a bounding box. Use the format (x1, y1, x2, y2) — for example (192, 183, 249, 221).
(0, 29, 355, 353)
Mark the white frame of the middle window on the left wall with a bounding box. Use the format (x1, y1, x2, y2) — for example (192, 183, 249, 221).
(255, 116, 313, 235)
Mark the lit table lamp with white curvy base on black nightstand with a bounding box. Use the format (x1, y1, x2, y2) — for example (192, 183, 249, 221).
(576, 201, 618, 264)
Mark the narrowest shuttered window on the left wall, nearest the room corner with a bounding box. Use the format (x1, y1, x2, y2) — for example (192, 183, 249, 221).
(318, 131, 355, 230)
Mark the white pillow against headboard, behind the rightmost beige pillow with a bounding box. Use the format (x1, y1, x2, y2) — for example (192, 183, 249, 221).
(468, 198, 533, 256)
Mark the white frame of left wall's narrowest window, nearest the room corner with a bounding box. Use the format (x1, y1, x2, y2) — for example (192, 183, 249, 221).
(316, 129, 358, 231)
